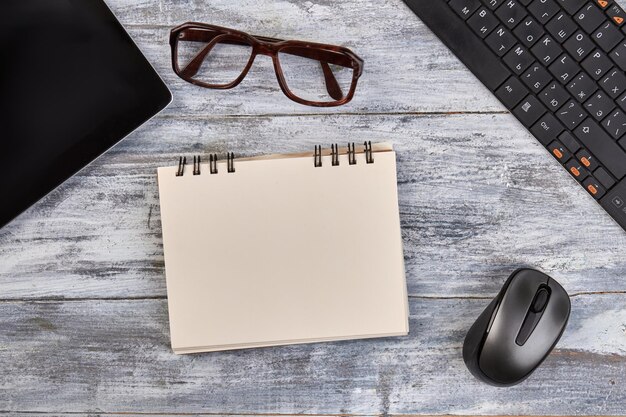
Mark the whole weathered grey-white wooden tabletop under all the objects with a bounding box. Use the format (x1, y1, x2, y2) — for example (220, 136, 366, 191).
(0, 0, 626, 416)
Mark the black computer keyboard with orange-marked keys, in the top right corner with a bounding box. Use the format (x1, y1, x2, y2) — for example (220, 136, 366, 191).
(404, 0, 626, 230)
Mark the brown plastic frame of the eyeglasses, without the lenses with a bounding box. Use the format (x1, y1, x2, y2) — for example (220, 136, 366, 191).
(170, 22, 363, 107)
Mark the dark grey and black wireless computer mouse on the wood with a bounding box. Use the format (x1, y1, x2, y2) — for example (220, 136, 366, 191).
(463, 269, 570, 387)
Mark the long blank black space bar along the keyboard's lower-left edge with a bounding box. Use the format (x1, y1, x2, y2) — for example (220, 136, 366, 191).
(405, 0, 511, 91)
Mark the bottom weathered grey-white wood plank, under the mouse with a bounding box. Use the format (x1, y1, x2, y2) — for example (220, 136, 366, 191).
(0, 295, 626, 415)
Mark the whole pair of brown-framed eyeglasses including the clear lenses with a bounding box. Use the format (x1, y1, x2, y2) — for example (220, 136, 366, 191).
(170, 22, 363, 107)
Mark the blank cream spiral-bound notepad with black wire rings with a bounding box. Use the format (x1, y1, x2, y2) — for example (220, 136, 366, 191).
(158, 144, 409, 354)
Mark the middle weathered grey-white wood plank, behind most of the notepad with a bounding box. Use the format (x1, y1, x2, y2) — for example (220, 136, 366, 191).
(0, 115, 626, 299)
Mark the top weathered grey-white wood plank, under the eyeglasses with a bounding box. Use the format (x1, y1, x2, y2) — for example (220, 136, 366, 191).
(102, 0, 504, 116)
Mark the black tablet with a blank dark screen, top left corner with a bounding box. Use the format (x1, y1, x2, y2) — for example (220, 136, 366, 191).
(0, 0, 172, 227)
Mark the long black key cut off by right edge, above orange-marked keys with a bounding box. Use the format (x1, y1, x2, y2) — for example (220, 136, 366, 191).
(574, 119, 626, 179)
